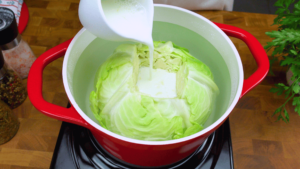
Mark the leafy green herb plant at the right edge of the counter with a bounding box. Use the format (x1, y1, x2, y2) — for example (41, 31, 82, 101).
(265, 0, 300, 122)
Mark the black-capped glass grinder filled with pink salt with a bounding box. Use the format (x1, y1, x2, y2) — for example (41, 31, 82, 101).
(0, 7, 36, 79)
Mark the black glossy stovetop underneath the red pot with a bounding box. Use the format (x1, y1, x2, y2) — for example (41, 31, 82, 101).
(50, 119, 234, 169)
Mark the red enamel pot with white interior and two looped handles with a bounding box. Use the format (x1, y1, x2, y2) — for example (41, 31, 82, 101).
(28, 5, 269, 167)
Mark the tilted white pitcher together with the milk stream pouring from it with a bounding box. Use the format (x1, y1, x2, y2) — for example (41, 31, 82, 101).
(79, 0, 154, 78)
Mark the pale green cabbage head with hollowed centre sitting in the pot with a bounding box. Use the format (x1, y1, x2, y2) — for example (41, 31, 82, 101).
(90, 41, 219, 141)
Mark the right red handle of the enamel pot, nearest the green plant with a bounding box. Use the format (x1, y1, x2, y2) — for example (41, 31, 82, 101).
(215, 23, 270, 98)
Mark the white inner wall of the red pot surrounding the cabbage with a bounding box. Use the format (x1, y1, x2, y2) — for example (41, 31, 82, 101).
(63, 5, 243, 145)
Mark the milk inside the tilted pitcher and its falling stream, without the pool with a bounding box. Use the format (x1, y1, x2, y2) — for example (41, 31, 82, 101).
(101, 0, 154, 74)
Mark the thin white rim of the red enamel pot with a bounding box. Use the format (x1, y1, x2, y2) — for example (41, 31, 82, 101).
(62, 4, 244, 145)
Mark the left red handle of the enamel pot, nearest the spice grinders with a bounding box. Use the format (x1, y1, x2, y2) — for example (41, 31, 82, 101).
(27, 39, 90, 128)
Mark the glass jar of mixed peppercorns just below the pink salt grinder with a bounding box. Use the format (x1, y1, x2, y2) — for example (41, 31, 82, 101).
(0, 49, 27, 109)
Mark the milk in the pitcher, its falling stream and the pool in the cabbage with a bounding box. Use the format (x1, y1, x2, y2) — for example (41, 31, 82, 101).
(101, 0, 176, 98)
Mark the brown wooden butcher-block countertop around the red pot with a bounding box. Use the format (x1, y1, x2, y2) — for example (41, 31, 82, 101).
(0, 0, 300, 169)
